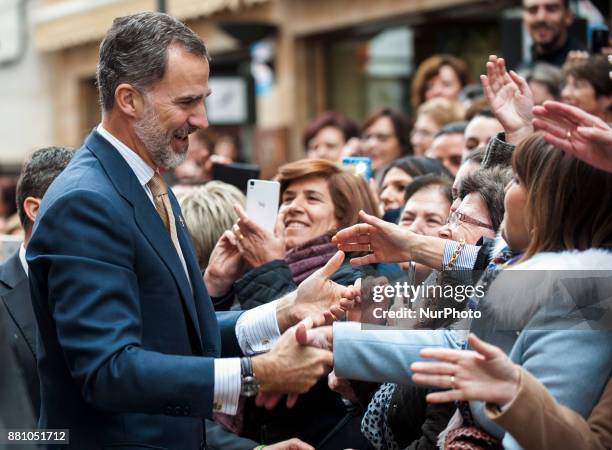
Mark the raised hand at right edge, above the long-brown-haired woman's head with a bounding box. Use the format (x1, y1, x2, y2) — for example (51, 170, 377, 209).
(533, 101, 612, 172)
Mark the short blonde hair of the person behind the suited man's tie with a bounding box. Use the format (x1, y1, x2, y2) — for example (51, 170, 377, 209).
(175, 181, 246, 270)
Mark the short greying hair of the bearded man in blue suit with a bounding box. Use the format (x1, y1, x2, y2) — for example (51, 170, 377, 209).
(96, 12, 208, 111)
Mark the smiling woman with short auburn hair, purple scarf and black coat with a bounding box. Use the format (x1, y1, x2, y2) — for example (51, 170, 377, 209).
(204, 159, 379, 448)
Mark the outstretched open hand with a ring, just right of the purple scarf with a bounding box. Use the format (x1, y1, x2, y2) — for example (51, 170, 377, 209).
(332, 211, 415, 266)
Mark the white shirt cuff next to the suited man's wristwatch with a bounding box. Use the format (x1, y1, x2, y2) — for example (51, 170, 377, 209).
(213, 358, 242, 416)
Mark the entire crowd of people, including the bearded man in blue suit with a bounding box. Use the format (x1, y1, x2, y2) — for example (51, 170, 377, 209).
(0, 0, 612, 450)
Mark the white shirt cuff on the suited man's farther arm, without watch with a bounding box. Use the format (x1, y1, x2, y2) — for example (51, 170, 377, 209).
(236, 301, 280, 355)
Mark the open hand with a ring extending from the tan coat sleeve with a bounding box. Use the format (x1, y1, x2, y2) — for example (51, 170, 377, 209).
(410, 334, 520, 407)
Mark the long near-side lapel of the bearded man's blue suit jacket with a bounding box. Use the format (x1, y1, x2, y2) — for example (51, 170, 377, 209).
(85, 131, 202, 347)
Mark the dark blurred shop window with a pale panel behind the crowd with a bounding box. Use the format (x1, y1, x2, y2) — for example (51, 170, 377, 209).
(322, 10, 501, 121)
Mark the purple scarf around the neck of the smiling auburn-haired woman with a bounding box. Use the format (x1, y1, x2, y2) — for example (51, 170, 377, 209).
(286, 234, 338, 284)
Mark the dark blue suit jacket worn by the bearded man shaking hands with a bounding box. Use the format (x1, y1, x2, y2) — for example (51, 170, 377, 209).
(27, 131, 240, 450)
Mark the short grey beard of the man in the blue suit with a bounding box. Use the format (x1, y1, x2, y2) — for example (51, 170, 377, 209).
(134, 102, 193, 169)
